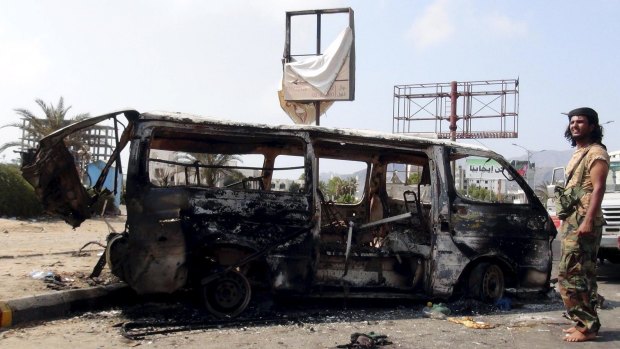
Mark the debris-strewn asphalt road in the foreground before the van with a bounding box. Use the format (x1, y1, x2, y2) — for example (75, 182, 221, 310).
(0, 231, 620, 349)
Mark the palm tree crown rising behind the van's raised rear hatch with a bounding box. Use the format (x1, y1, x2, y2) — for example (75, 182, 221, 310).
(0, 97, 90, 152)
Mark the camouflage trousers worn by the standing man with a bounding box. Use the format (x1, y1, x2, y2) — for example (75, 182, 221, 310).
(558, 213, 602, 333)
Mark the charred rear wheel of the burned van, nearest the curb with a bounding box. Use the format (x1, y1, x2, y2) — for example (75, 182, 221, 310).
(202, 271, 252, 317)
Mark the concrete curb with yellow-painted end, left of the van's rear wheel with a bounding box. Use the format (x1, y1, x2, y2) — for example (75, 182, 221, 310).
(0, 283, 135, 328)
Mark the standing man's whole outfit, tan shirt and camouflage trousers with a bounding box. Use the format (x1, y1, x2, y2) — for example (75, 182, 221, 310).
(558, 144, 609, 333)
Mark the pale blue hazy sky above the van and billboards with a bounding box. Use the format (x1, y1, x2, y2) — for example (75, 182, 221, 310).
(0, 0, 620, 161)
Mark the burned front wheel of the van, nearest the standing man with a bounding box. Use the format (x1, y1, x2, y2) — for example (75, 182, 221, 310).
(469, 263, 505, 303)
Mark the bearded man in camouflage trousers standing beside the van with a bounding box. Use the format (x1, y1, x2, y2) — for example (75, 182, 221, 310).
(558, 108, 609, 342)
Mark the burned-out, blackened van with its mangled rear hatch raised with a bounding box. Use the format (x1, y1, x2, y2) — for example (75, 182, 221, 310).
(23, 111, 556, 316)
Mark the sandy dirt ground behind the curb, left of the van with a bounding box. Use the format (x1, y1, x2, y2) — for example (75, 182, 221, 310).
(0, 216, 125, 300)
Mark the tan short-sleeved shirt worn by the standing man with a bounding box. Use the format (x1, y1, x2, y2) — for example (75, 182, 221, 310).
(566, 144, 609, 217)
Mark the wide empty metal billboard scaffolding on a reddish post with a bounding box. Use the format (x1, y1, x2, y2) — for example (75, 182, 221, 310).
(392, 79, 519, 140)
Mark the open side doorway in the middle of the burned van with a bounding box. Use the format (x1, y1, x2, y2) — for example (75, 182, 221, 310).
(314, 140, 431, 297)
